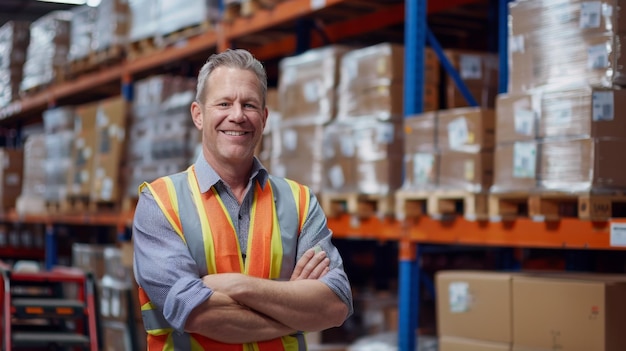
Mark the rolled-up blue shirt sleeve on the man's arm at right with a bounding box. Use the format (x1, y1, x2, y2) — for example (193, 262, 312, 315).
(297, 193, 354, 316)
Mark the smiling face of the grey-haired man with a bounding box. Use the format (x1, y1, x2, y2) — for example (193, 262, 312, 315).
(191, 67, 267, 164)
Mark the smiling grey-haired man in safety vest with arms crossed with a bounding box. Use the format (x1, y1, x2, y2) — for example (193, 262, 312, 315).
(133, 50, 353, 351)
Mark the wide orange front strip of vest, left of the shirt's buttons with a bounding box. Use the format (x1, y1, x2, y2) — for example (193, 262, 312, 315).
(202, 188, 243, 273)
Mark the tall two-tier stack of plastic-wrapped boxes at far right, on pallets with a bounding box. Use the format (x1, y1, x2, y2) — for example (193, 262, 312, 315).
(492, 0, 626, 192)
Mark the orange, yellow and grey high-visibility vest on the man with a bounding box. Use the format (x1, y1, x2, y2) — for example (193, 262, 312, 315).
(139, 166, 309, 351)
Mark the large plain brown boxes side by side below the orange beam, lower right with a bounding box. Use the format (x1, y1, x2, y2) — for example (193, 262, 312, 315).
(436, 271, 626, 351)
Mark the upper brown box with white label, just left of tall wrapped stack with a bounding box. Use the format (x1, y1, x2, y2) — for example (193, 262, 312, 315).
(437, 107, 495, 152)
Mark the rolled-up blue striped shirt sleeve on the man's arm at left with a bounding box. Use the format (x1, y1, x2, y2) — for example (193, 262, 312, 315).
(132, 188, 213, 332)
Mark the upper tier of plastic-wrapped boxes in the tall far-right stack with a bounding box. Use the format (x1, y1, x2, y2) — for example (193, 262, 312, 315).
(508, 0, 626, 92)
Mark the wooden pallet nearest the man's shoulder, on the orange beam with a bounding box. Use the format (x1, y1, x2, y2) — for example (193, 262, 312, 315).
(320, 193, 395, 218)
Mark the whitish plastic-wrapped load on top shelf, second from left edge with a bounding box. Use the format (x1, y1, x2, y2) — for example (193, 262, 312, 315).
(20, 11, 72, 92)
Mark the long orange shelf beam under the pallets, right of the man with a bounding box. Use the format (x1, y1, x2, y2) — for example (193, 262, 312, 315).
(328, 215, 626, 250)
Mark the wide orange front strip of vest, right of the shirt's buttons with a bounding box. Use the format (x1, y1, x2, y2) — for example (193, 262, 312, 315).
(246, 182, 274, 278)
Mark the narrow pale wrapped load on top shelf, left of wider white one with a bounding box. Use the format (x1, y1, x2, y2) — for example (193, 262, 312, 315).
(128, 0, 158, 42)
